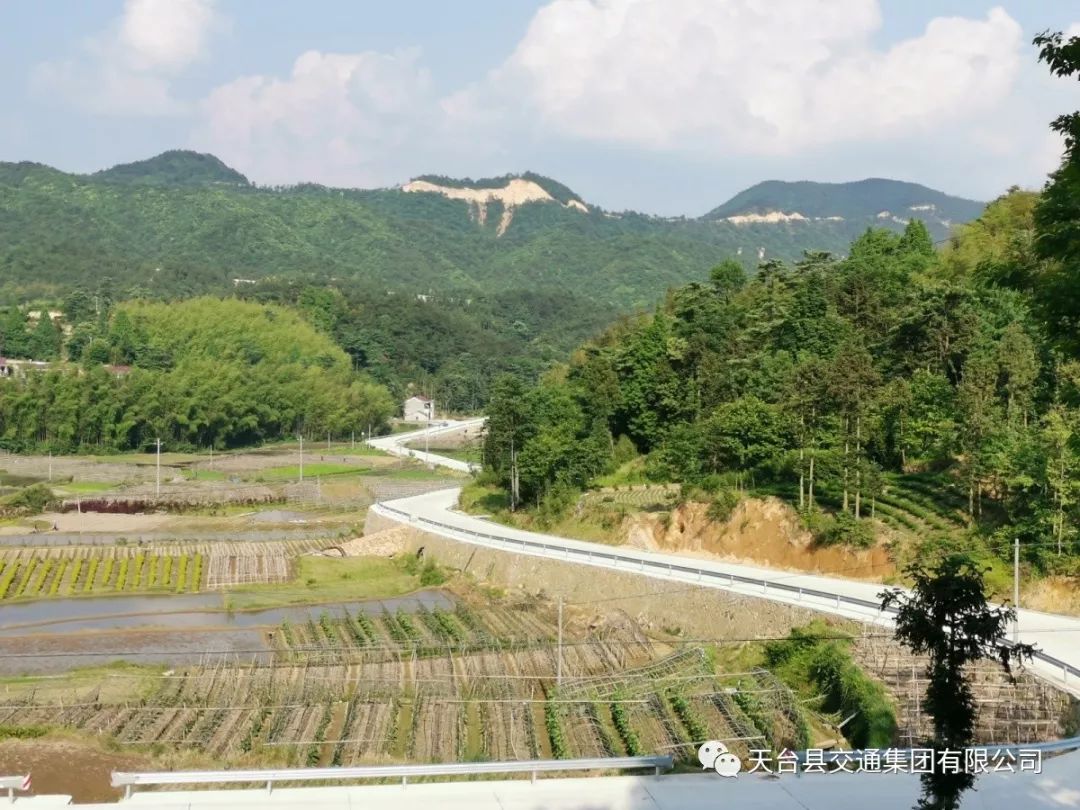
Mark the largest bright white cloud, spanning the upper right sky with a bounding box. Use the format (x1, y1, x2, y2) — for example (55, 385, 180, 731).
(447, 0, 1022, 154)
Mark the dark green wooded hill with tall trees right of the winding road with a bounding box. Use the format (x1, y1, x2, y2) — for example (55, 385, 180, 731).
(485, 181, 1080, 573)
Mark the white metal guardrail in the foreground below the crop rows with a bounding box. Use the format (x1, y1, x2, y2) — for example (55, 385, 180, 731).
(112, 755, 674, 798)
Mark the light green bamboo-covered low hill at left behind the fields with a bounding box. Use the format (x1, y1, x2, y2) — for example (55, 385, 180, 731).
(0, 298, 394, 453)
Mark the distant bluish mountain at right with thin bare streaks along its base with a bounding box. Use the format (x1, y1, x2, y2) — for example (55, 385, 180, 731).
(704, 177, 985, 232)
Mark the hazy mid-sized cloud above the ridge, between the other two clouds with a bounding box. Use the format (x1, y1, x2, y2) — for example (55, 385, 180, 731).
(193, 50, 440, 185)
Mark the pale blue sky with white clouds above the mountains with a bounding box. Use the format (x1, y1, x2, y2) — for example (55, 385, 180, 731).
(0, 0, 1080, 215)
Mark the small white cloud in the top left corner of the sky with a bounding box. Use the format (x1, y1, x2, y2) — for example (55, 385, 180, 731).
(31, 0, 218, 116)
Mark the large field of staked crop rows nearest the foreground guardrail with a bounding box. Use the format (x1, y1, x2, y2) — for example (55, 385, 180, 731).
(0, 602, 795, 766)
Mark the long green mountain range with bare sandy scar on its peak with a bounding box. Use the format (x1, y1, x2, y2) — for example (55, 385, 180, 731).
(0, 151, 977, 311)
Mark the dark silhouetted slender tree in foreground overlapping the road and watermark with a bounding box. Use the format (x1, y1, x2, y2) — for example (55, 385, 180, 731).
(881, 554, 1034, 810)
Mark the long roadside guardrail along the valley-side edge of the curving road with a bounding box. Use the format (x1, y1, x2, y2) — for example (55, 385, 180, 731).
(372, 503, 1080, 691)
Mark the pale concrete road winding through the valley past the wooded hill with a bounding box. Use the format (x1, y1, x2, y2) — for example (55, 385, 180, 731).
(372, 419, 1080, 698)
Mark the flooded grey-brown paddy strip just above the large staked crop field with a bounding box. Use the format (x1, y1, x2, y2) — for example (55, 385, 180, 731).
(0, 589, 455, 637)
